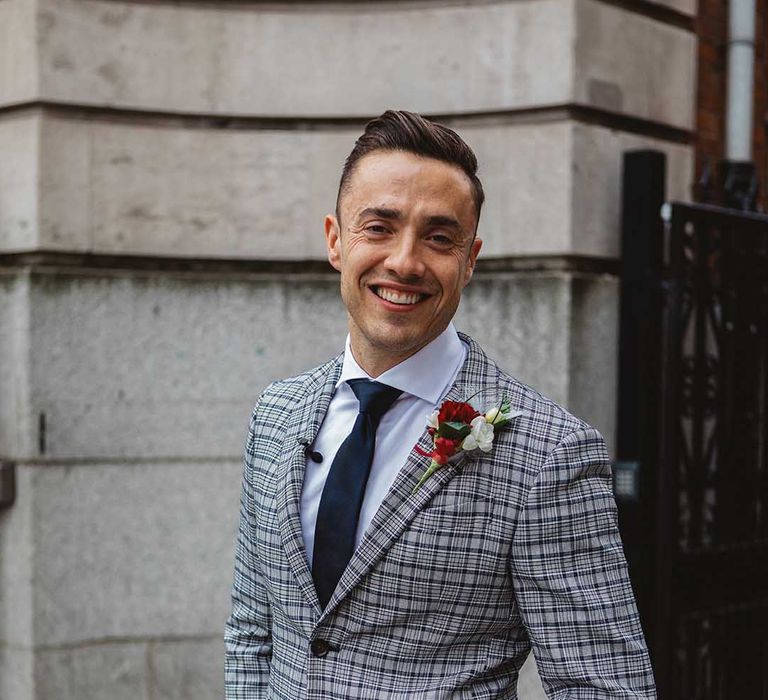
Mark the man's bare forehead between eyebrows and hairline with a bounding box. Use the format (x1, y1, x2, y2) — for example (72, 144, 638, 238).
(340, 151, 474, 219)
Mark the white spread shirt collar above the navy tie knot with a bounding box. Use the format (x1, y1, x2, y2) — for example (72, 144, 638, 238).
(336, 323, 466, 406)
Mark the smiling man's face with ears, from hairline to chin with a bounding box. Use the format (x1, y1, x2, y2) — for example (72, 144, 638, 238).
(325, 151, 482, 376)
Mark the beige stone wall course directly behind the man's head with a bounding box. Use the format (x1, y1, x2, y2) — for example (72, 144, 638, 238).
(0, 112, 692, 260)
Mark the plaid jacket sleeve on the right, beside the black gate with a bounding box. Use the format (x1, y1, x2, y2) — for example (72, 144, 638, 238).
(511, 427, 656, 700)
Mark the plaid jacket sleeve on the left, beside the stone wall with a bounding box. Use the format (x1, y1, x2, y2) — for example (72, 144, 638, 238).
(224, 405, 272, 700)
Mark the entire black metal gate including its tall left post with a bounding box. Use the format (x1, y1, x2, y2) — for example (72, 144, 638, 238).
(615, 151, 768, 700)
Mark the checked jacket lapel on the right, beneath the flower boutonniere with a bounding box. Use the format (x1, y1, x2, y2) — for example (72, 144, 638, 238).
(322, 333, 498, 618)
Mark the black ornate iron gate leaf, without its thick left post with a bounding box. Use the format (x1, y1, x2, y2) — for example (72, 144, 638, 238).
(656, 204, 768, 700)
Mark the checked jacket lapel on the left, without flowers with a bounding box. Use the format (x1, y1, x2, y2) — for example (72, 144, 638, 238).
(276, 355, 343, 615)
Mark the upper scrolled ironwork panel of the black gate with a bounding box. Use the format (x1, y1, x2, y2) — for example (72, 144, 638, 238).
(664, 204, 768, 556)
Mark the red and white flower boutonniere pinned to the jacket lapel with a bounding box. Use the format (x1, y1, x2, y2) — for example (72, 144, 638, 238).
(413, 398, 522, 493)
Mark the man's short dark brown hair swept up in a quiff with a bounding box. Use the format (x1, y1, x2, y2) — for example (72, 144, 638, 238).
(336, 109, 485, 228)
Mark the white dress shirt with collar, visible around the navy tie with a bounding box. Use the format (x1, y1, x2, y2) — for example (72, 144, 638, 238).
(301, 324, 467, 568)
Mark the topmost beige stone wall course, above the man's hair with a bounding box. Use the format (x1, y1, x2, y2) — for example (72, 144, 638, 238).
(0, 0, 694, 128)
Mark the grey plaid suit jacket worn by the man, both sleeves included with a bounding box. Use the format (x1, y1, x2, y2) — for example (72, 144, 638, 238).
(225, 336, 656, 700)
